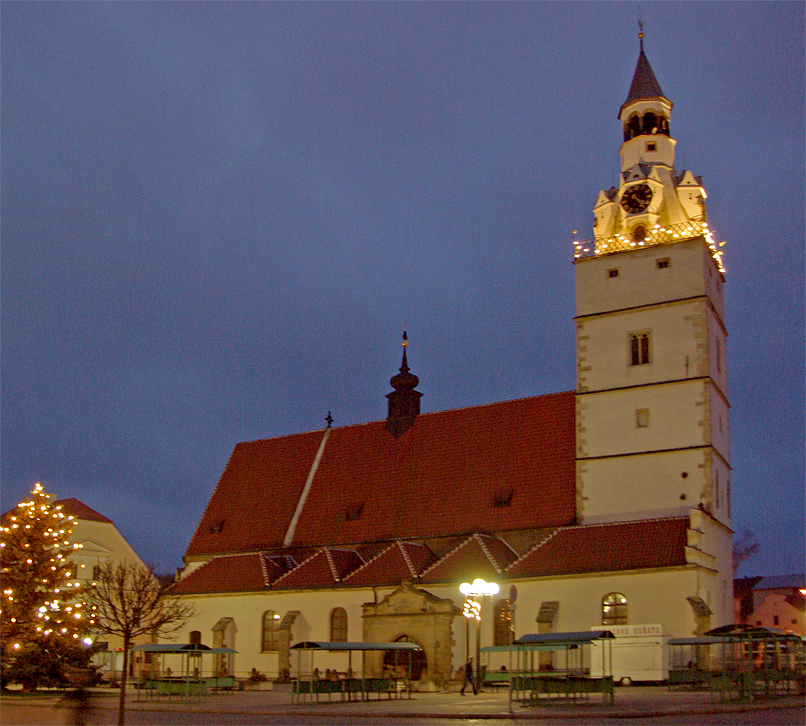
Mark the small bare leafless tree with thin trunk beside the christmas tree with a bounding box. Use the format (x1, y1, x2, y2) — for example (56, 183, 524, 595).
(86, 562, 195, 726)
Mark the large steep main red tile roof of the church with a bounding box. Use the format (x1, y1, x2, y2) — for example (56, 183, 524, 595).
(185, 391, 576, 557)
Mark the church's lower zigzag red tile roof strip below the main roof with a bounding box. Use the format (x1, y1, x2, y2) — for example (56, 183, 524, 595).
(174, 517, 689, 595)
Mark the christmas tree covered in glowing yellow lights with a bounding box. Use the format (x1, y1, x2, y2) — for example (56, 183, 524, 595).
(0, 483, 92, 687)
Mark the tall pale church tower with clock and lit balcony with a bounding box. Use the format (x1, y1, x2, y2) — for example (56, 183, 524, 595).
(575, 38, 730, 540)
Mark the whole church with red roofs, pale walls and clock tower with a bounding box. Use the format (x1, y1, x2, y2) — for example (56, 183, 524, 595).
(175, 40, 733, 684)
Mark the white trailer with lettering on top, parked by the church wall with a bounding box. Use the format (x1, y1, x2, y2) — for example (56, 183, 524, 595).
(591, 624, 669, 686)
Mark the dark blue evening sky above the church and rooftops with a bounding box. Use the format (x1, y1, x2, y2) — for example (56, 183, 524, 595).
(0, 2, 804, 574)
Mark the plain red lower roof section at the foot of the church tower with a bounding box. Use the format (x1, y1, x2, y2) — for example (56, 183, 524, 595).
(506, 517, 689, 577)
